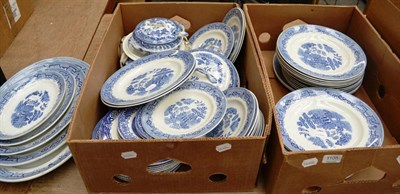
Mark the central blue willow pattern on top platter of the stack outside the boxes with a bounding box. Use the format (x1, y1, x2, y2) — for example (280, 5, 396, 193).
(11, 90, 50, 128)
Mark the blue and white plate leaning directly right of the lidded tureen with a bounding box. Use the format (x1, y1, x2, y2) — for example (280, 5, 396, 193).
(189, 22, 235, 58)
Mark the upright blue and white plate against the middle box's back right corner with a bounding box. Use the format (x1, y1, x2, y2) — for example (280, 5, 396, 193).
(222, 7, 246, 63)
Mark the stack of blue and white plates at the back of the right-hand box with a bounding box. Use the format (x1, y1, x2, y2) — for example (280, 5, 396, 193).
(273, 25, 367, 93)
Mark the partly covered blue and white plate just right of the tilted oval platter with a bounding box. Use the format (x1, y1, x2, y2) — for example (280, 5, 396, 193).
(189, 49, 240, 91)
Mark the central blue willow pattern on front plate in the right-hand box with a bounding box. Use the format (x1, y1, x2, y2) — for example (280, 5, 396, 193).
(297, 109, 352, 149)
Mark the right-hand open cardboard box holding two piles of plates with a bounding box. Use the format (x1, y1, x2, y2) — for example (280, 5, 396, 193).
(244, 0, 400, 194)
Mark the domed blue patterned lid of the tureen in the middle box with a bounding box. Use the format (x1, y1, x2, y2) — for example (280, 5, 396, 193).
(133, 18, 183, 44)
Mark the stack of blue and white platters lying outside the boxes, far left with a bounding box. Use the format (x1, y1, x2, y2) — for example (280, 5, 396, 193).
(0, 57, 89, 182)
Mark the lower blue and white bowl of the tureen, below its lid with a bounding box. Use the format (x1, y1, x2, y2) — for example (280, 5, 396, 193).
(128, 34, 185, 54)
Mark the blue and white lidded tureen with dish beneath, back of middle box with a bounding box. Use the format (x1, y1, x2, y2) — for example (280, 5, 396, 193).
(122, 18, 187, 60)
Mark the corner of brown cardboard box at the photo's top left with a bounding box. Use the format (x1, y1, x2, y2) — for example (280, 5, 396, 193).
(0, 0, 33, 58)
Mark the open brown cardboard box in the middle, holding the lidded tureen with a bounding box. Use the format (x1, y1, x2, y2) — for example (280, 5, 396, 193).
(67, 3, 272, 192)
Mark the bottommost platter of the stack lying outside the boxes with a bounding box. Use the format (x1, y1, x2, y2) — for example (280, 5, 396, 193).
(0, 145, 72, 183)
